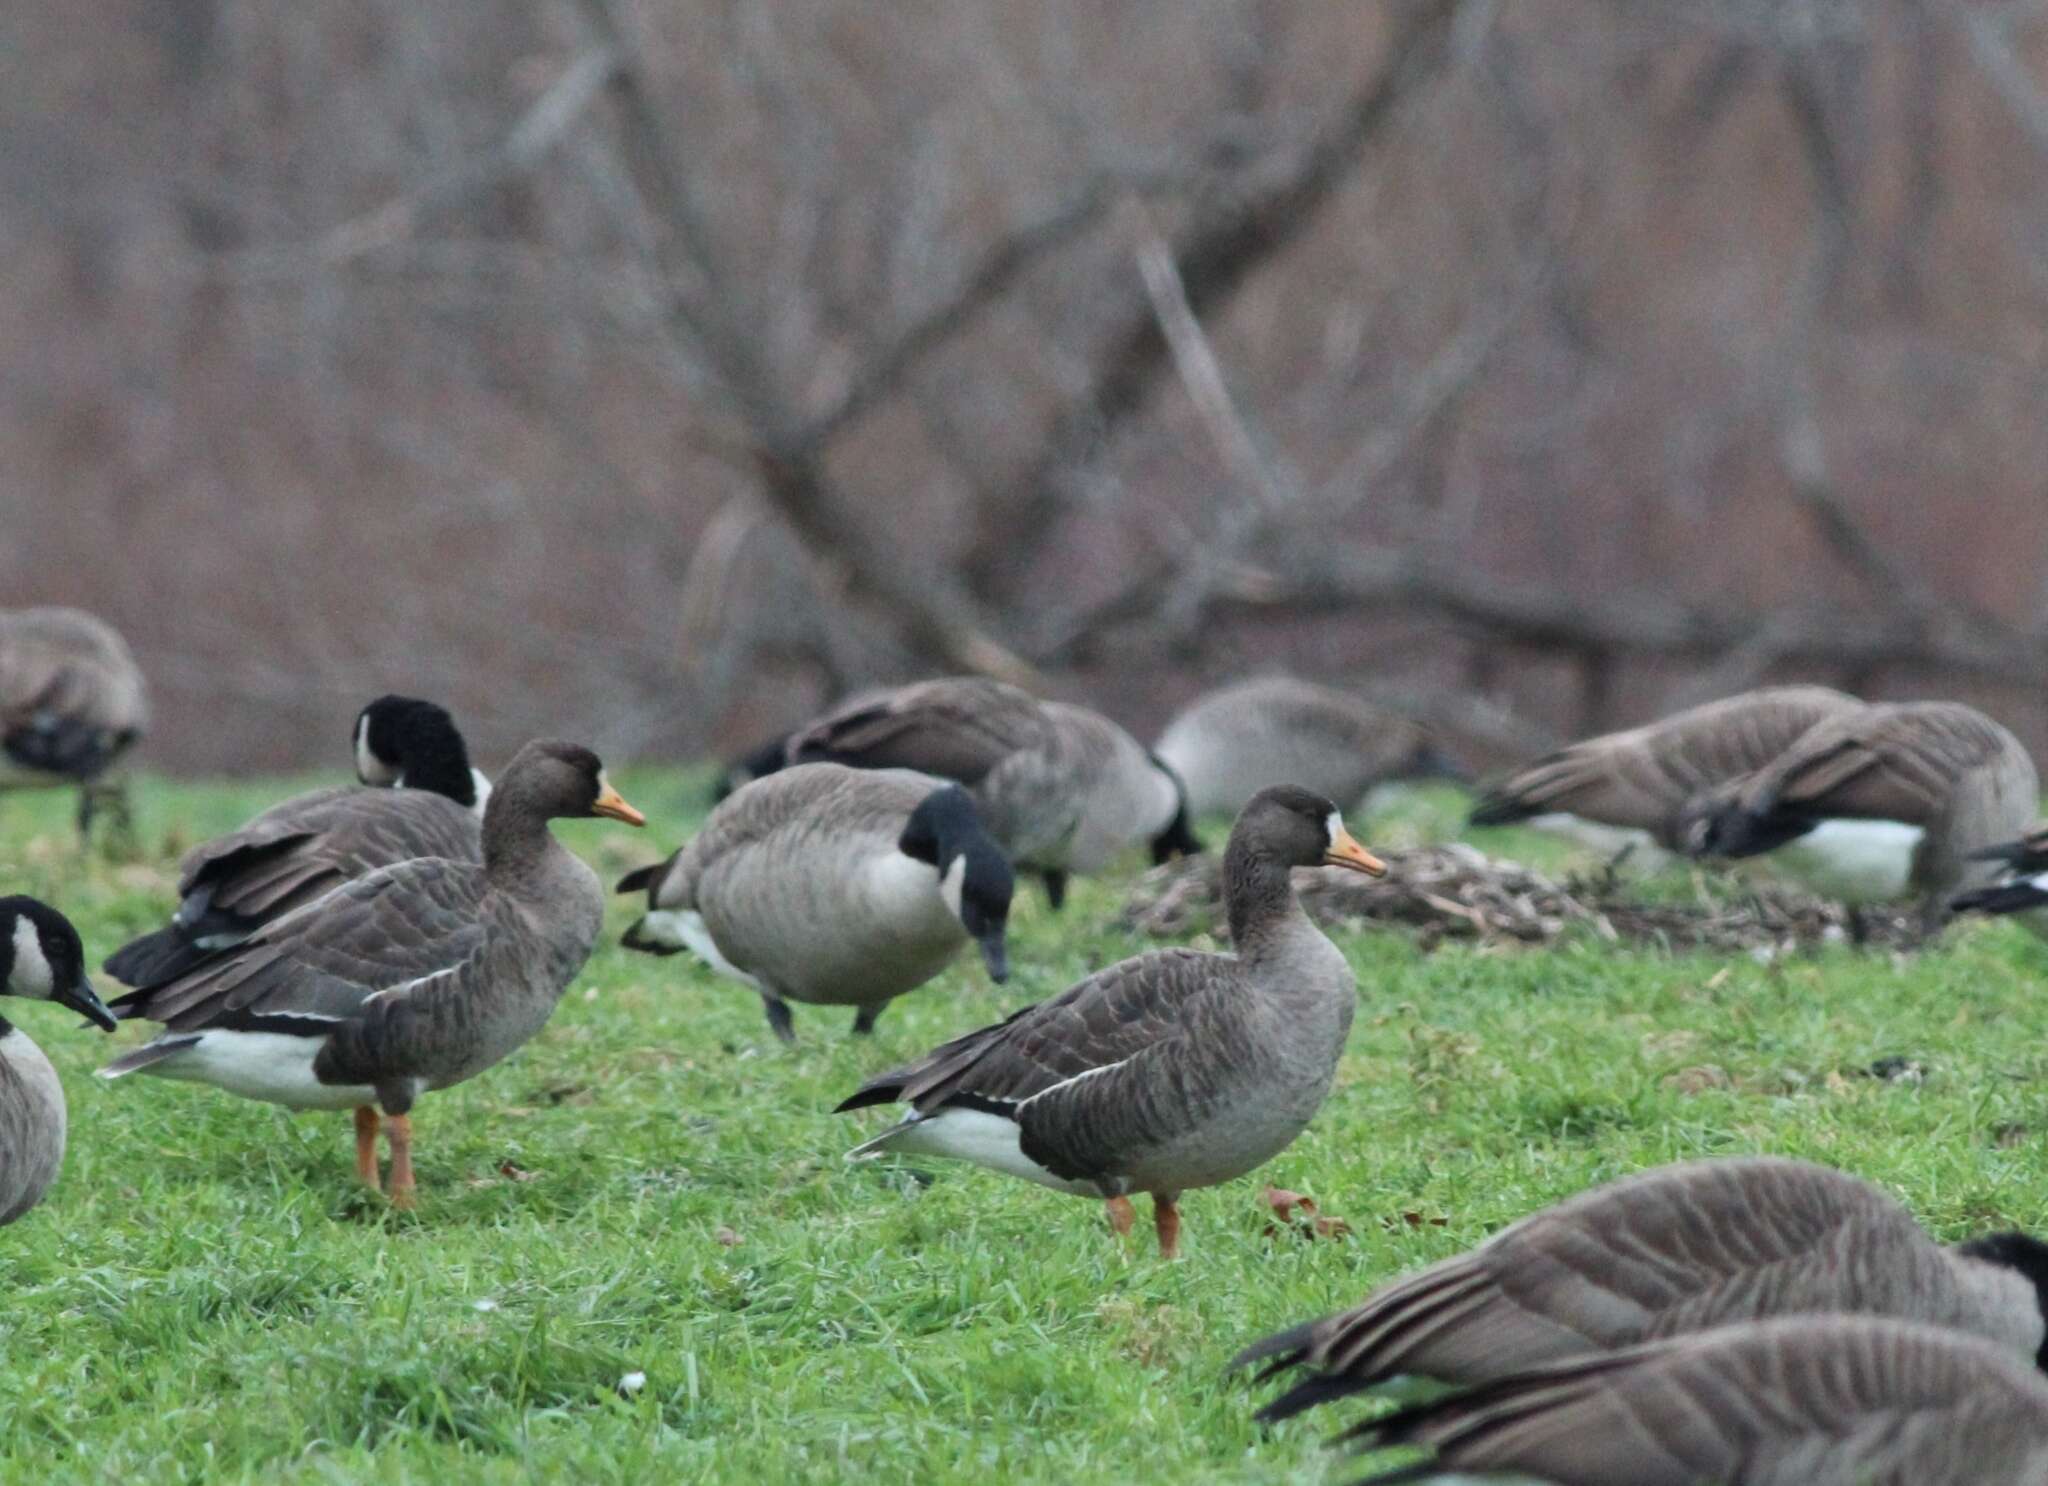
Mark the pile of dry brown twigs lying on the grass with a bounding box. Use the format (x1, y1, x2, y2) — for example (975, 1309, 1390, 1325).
(1122, 841, 1921, 954)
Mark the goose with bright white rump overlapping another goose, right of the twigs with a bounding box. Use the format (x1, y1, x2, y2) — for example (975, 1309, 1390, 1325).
(1686, 702, 2040, 929)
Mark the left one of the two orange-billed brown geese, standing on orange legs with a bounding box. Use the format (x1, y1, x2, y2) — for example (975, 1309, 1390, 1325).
(100, 741, 645, 1206)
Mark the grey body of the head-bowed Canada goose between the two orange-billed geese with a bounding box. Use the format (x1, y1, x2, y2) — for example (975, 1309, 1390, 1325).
(647, 763, 983, 1007)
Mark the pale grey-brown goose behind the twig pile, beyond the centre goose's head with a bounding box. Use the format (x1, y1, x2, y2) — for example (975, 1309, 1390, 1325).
(1153, 675, 1456, 815)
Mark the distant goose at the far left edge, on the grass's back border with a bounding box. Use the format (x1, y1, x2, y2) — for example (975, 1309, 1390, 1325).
(0, 608, 150, 835)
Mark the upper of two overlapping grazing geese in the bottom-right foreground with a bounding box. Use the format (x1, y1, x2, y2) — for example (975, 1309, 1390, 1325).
(1233, 1156, 2048, 1421)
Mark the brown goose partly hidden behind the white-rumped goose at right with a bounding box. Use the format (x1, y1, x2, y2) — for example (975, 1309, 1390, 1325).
(1470, 686, 1862, 866)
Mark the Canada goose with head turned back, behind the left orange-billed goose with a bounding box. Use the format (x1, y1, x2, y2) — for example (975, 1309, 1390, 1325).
(104, 696, 489, 991)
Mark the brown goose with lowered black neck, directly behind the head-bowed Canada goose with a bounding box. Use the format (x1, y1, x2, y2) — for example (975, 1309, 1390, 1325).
(788, 675, 1202, 909)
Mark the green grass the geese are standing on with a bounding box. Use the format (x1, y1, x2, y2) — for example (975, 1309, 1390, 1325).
(0, 772, 2048, 1486)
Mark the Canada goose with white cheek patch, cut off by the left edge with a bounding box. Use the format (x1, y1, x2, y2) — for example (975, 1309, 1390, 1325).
(0, 897, 115, 1224)
